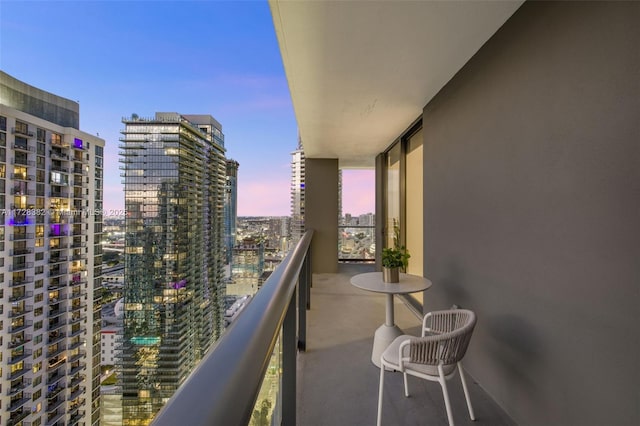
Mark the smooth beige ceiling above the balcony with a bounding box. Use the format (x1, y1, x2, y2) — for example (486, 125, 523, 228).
(270, 0, 522, 168)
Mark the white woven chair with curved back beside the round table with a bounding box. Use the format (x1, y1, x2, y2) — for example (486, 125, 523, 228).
(377, 309, 476, 426)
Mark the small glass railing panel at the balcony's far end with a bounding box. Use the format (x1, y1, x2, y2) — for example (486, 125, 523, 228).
(338, 225, 376, 262)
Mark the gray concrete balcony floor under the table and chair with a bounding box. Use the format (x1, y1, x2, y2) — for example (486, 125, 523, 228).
(297, 264, 514, 426)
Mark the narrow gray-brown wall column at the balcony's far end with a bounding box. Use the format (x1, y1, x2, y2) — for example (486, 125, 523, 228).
(304, 158, 338, 273)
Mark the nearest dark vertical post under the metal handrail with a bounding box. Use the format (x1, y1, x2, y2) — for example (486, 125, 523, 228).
(281, 293, 304, 426)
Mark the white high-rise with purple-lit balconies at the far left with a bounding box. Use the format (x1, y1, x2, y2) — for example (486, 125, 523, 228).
(0, 72, 104, 426)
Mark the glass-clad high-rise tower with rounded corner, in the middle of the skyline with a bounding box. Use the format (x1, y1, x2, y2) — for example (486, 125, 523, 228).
(120, 113, 226, 425)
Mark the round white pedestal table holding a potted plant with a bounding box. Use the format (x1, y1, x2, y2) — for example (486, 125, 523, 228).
(351, 272, 432, 367)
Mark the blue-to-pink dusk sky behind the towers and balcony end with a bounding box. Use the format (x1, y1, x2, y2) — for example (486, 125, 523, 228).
(0, 0, 374, 216)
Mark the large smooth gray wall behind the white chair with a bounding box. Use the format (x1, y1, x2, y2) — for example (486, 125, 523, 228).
(422, 2, 640, 425)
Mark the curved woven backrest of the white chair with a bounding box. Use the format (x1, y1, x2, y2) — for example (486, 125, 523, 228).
(409, 309, 476, 365)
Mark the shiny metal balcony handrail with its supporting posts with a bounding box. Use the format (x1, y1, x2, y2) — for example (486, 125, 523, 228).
(152, 230, 313, 426)
